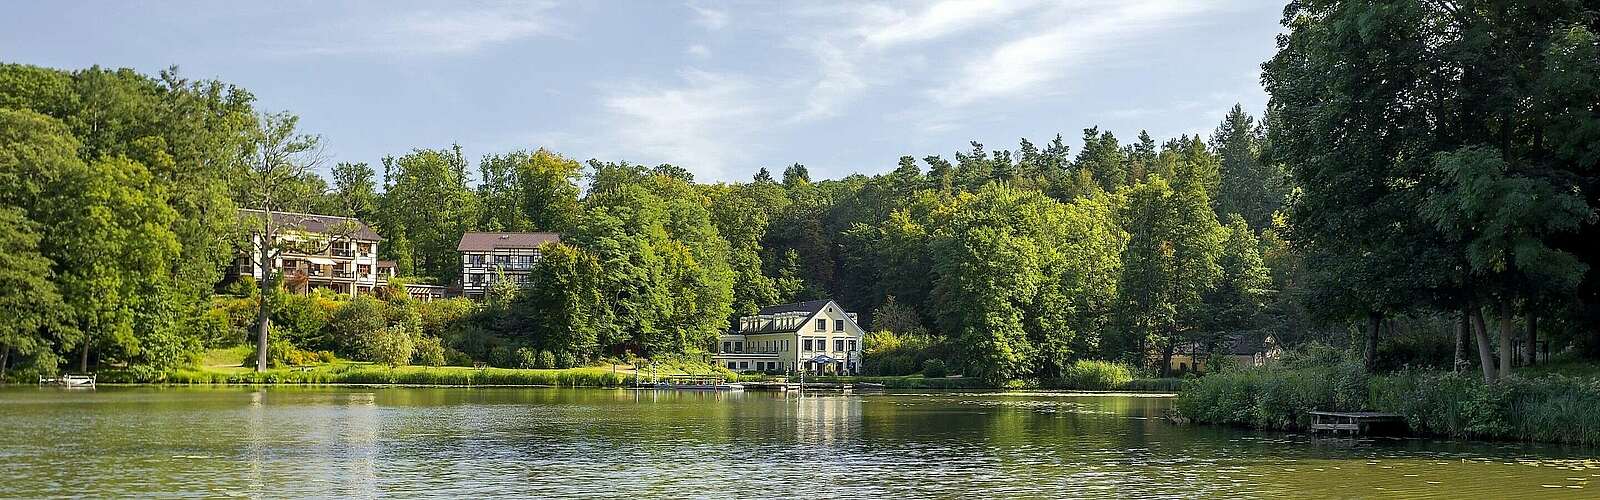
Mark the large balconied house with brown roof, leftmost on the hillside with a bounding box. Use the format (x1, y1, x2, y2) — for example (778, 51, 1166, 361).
(229, 210, 384, 295)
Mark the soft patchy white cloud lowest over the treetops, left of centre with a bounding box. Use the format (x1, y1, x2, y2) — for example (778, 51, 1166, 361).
(602, 69, 771, 179)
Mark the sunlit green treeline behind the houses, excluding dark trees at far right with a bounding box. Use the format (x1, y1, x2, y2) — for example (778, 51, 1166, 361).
(0, 64, 1302, 383)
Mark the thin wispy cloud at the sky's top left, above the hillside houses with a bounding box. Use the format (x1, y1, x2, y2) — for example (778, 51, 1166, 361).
(285, 2, 557, 56)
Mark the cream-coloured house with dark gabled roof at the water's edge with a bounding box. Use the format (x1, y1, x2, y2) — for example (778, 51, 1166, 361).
(712, 298, 866, 375)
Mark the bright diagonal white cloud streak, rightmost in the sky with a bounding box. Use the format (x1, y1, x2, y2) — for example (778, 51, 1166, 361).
(928, 0, 1216, 106)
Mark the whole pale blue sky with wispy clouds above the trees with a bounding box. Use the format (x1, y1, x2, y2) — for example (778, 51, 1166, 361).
(0, 0, 1283, 181)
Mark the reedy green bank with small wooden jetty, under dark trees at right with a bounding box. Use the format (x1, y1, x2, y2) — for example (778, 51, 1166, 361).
(1178, 362, 1600, 446)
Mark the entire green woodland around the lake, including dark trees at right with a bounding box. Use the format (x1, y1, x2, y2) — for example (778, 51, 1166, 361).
(0, 2, 1600, 383)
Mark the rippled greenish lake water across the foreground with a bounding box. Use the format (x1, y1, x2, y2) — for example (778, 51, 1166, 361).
(0, 386, 1600, 498)
